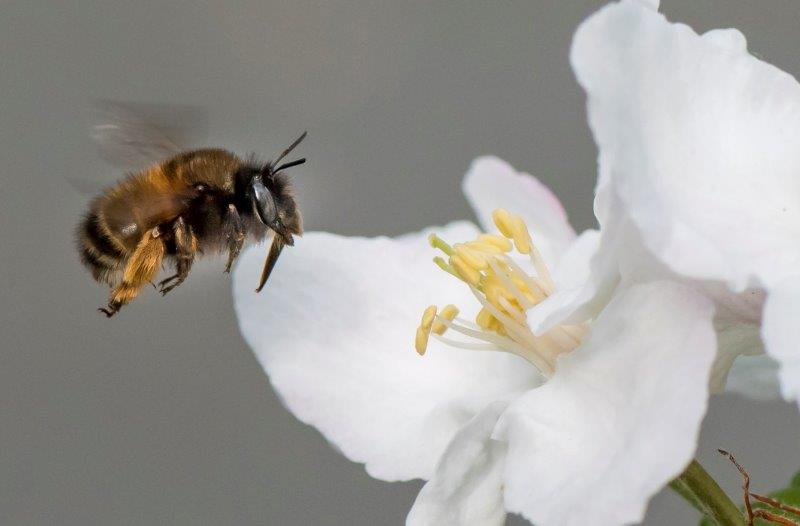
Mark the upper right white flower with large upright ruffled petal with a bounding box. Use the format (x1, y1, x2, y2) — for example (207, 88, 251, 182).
(531, 0, 800, 406)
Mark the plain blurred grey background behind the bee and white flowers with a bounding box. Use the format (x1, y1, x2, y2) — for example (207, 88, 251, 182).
(0, 0, 800, 525)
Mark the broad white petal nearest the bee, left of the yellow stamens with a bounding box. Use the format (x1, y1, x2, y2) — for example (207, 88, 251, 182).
(233, 222, 535, 480)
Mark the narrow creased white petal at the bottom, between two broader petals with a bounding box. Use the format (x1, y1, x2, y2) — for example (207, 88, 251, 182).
(406, 402, 508, 526)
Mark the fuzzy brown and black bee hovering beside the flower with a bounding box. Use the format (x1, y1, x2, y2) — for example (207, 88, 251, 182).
(77, 106, 306, 318)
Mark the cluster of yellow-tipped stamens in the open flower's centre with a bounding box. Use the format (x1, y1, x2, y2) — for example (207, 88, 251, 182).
(415, 209, 586, 377)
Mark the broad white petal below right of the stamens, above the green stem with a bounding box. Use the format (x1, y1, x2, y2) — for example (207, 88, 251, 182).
(499, 282, 715, 526)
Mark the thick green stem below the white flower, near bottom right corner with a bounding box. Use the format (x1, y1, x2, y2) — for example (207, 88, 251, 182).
(669, 460, 745, 526)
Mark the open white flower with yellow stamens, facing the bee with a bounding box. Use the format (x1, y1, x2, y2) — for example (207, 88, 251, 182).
(234, 158, 716, 526)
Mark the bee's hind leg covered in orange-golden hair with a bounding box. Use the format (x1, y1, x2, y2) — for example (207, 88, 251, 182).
(103, 227, 166, 318)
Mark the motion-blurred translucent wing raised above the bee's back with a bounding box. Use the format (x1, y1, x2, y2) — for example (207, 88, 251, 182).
(91, 100, 207, 169)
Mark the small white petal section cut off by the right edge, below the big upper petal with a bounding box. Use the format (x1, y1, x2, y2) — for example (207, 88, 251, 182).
(762, 277, 800, 400)
